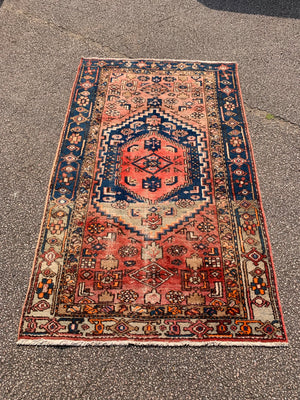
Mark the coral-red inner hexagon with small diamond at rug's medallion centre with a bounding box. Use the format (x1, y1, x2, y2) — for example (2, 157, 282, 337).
(117, 132, 188, 203)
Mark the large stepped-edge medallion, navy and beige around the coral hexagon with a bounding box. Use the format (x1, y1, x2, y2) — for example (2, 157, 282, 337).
(91, 109, 212, 240)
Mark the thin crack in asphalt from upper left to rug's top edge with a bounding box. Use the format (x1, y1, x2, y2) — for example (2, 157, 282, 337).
(5, 4, 129, 58)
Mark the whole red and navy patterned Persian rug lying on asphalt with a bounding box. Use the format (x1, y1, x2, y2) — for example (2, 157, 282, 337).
(18, 59, 287, 346)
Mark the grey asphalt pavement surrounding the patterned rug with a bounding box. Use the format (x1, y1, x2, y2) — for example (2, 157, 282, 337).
(0, 0, 300, 400)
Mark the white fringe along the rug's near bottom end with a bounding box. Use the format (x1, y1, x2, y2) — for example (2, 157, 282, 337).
(17, 339, 289, 347)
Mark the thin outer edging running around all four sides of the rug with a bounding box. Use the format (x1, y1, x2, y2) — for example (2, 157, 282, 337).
(17, 56, 289, 347)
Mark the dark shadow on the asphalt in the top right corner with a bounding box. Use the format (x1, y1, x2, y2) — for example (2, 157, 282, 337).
(197, 0, 300, 18)
